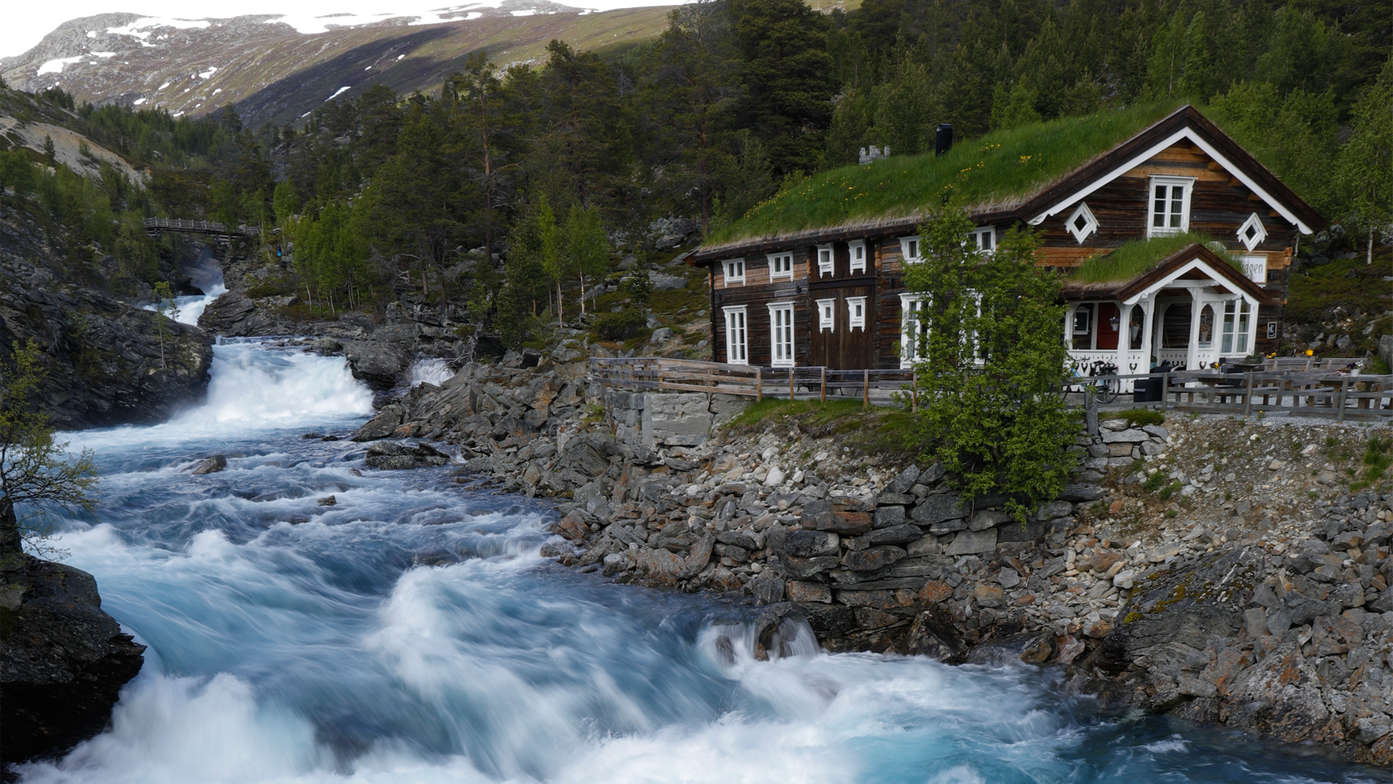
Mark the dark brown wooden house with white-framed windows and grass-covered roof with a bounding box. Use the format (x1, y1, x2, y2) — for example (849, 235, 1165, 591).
(688, 106, 1323, 373)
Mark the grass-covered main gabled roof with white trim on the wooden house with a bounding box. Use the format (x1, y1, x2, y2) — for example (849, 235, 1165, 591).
(688, 104, 1325, 263)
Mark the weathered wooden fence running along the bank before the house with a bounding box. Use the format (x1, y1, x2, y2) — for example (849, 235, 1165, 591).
(589, 356, 1393, 421)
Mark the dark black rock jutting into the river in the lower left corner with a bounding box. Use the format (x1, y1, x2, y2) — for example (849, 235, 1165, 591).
(0, 500, 145, 765)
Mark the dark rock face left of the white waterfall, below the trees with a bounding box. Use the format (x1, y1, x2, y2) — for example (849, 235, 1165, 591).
(0, 253, 213, 429)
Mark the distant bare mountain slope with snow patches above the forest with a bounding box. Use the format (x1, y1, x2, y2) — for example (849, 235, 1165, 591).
(0, 0, 671, 125)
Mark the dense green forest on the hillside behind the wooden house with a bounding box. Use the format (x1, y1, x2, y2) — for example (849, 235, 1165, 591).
(0, 0, 1393, 344)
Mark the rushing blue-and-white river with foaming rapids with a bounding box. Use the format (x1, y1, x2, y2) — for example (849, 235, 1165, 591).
(13, 343, 1386, 784)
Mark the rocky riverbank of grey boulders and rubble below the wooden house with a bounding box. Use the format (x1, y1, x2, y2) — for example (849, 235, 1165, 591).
(355, 345, 1393, 765)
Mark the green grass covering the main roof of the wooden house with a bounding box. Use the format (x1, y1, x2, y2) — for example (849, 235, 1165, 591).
(708, 102, 1176, 244)
